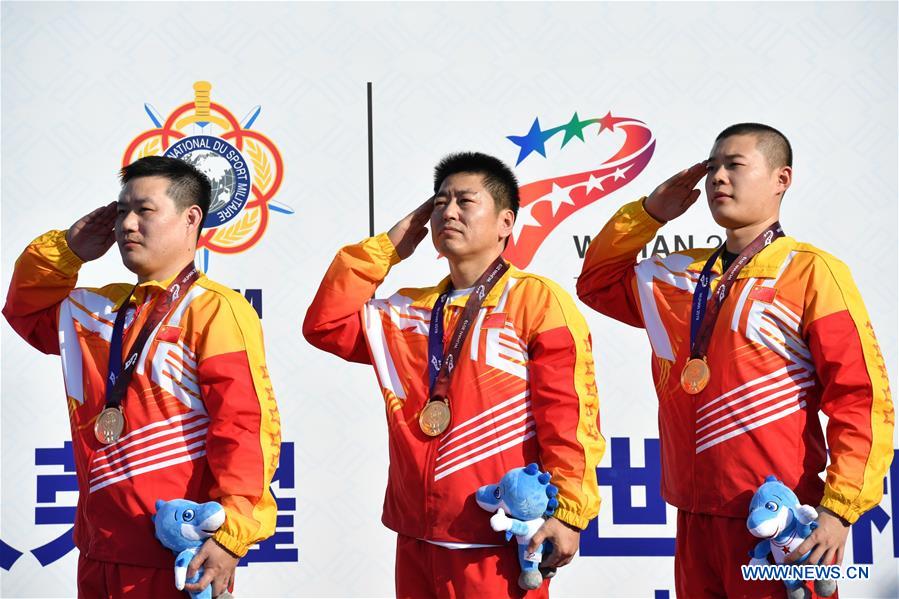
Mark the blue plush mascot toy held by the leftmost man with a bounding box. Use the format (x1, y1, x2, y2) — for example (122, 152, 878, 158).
(153, 499, 225, 599)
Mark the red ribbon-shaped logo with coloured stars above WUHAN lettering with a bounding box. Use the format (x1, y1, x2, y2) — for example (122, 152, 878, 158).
(503, 112, 655, 268)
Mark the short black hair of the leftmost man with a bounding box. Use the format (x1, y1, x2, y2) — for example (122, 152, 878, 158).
(119, 156, 212, 238)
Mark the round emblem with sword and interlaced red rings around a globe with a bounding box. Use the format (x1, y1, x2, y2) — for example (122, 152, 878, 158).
(122, 81, 293, 270)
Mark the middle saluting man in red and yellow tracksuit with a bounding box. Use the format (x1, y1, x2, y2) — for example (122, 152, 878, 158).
(303, 154, 604, 598)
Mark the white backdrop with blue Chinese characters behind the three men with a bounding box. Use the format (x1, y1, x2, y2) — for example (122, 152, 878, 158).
(0, 2, 899, 597)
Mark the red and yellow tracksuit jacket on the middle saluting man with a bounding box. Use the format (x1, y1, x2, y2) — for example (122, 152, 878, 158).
(303, 234, 604, 544)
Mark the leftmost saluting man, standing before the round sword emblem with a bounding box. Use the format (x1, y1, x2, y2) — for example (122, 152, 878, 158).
(3, 156, 281, 598)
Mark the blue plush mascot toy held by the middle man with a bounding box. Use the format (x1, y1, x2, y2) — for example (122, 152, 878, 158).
(475, 464, 559, 590)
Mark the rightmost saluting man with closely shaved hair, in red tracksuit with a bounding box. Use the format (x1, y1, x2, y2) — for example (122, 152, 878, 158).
(577, 123, 893, 599)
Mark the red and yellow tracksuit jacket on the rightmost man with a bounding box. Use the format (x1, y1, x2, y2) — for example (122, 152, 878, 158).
(577, 200, 893, 522)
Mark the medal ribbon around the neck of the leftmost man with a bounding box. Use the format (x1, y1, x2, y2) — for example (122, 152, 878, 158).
(106, 263, 200, 408)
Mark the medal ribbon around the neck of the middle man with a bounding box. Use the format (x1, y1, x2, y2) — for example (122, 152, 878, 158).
(428, 256, 509, 403)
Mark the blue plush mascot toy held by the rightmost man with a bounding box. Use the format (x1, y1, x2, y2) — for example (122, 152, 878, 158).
(746, 476, 837, 599)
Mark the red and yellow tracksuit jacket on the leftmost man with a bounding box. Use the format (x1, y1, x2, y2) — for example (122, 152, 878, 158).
(3, 231, 281, 568)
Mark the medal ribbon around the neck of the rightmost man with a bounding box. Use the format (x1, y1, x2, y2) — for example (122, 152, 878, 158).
(690, 222, 784, 359)
